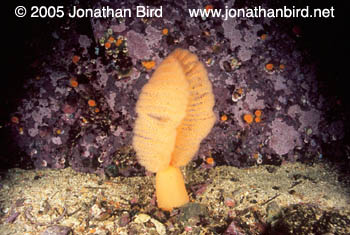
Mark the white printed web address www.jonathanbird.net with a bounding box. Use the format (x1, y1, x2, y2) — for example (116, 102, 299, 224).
(188, 6, 335, 20)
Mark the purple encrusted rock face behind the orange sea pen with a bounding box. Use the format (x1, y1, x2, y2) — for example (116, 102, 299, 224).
(4, 2, 347, 175)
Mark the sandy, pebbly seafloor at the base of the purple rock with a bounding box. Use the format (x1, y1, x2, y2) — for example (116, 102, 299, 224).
(0, 163, 350, 235)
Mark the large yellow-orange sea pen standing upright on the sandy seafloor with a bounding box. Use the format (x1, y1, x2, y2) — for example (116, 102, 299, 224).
(133, 49, 215, 210)
